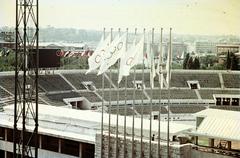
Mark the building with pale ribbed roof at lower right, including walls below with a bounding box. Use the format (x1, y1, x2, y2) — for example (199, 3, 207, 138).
(190, 109, 240, 158)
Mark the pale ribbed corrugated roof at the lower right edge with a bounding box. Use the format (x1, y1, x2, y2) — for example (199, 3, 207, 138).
(192, 109, 240, 141)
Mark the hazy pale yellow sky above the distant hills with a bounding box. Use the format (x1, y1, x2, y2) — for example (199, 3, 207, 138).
(0, 0, 240, 36)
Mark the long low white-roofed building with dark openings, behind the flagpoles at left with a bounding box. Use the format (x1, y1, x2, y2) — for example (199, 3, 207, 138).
(0, 104, 193, 158)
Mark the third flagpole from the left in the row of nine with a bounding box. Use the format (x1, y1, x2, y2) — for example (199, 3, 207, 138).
(115, 28, 121, 158)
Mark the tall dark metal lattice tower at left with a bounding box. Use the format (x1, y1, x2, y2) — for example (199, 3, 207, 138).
(13, 0, 39, 158)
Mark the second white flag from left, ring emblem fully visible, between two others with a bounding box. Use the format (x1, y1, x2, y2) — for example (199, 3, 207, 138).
(98, 33, 127, 75)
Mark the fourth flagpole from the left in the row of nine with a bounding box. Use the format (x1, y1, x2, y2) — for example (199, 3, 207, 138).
(123, 28, 128, 157)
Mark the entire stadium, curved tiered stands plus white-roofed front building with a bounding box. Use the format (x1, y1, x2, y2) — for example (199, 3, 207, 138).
(0, 70, 240, 158)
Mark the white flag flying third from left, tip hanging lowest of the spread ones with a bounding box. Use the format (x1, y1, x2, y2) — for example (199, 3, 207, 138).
(118, 36, 144, 83)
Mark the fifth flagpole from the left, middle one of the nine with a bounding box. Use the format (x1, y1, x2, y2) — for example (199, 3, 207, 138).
(132, 28, 137, 158)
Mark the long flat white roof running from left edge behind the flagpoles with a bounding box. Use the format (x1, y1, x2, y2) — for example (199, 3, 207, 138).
(0, 104, 193, 143)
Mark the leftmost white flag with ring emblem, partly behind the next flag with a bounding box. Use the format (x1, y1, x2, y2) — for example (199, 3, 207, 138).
(86, 35, 111, 73)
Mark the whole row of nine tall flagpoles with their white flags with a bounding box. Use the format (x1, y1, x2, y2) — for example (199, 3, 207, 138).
(93, 28, 172, 158)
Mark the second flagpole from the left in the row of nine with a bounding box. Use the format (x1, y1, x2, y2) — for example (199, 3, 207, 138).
(108, 28, 113, 157)
